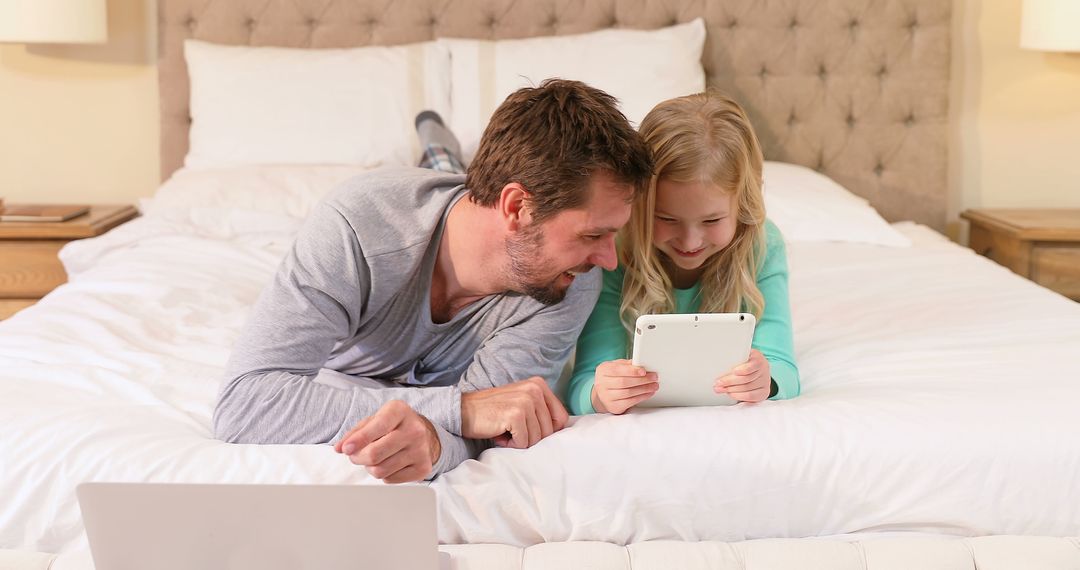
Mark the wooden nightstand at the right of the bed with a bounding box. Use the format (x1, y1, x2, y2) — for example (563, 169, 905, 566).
(960, 209, 1080, 301)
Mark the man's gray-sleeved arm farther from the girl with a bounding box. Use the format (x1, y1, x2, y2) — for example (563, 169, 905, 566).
(214, 203, 470, 474)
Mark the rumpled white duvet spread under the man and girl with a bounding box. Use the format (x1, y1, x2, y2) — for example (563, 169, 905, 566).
(0, 170, 1080, 552)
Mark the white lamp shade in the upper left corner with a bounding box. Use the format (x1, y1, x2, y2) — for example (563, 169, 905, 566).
(0, 0, 108, 43)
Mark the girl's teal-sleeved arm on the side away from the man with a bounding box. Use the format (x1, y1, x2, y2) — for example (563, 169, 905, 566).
(756, 220, 800, 399)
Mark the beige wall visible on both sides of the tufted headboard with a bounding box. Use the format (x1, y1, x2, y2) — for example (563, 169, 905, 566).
(0, 0, 1080, 223)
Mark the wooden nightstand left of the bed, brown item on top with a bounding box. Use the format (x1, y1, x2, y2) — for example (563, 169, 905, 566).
(0, 206, 138, 320)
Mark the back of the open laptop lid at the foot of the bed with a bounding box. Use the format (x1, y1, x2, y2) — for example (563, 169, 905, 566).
(76, 483, 450, 570)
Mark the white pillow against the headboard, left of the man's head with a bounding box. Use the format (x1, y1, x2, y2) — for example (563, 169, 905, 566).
(184, 40, 450, 168)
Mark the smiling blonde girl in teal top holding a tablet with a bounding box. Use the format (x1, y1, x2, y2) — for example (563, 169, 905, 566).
(567, 92, 799, 415)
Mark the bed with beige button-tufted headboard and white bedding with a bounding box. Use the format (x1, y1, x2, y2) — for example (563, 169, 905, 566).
(0, 0, 1080, 570)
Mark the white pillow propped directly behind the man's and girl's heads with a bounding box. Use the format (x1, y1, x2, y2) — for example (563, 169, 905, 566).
(438, 18, 705, 161)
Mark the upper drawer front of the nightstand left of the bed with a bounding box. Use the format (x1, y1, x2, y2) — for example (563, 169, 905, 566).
(0, 240, 67, 299)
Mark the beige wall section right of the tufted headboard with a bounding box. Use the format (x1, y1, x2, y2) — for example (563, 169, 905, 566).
(950, 0, 1080, 231)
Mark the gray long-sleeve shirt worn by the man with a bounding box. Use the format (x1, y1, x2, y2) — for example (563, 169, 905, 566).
(214, 168, 599, 477)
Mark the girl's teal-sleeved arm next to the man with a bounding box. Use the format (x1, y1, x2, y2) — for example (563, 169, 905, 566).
(566, 267, 626, 416)
